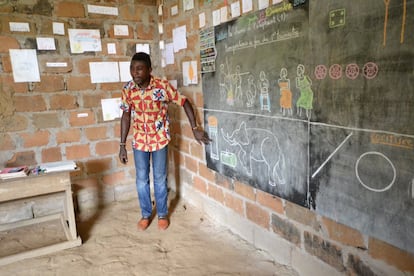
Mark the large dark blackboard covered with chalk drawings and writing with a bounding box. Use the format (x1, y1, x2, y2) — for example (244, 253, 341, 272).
(202, 0, 414, 253)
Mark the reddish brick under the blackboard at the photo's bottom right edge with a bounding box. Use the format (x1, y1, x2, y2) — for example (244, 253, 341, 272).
(368, 238, 414, 273)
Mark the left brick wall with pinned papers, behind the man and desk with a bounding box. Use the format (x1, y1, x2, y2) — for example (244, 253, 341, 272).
(0, 0, 161, 209)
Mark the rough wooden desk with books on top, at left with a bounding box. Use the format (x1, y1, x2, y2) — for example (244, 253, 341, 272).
(0, 171, 82, 265)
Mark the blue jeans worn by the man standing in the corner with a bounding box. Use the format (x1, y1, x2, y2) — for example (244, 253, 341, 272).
(133, 146, 168, 218)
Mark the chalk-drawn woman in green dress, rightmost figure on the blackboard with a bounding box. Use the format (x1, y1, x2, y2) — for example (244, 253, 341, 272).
(296, 64, 313, 119)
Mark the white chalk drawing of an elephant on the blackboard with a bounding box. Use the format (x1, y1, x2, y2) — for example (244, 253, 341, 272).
(221, 122, 285, 186)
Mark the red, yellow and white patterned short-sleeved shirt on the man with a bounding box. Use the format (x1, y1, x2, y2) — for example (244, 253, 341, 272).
(120, 76, 187, 152)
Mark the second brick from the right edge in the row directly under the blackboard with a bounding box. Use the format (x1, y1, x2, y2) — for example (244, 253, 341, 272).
(322, 218, 366, 249)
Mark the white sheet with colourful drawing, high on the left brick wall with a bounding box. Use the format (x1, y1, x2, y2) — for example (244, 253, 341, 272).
(68, 29, 102, 54)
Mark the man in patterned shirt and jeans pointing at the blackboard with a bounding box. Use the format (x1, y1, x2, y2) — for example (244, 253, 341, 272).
(119, 52, 210, 230)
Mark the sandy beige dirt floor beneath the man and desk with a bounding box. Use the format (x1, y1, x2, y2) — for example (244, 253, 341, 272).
(0, 196, 298, 276)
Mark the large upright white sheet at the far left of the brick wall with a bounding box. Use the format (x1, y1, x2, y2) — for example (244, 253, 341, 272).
(9, 49, 40, 82)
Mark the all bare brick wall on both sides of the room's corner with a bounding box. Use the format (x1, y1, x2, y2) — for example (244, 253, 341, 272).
(0, 0, 414, 275)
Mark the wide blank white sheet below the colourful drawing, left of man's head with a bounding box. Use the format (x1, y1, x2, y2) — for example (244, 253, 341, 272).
(89, 61, 119, 83)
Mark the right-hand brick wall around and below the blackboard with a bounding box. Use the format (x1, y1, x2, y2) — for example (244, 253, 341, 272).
(160, 0, 414, 275)
